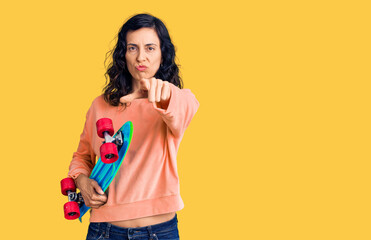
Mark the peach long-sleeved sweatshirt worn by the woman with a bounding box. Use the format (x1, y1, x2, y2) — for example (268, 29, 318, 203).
(68, 84, 199, 222)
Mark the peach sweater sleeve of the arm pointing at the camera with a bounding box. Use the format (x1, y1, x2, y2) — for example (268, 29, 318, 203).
(154, 84, 200, 137)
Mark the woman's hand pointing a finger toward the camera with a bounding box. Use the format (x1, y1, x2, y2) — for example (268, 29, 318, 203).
(120, 77, 171, 108)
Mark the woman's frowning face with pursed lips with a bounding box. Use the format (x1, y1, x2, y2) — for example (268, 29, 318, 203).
(125, 28, 162, 81)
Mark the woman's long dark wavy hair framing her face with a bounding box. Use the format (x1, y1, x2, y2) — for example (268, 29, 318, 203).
(103, 14, 183, 106)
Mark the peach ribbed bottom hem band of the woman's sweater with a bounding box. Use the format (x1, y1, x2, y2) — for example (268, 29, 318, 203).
(90, 194, 184, 222)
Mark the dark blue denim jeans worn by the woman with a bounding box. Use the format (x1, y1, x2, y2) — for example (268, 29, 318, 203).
(86, 214, 179, 240)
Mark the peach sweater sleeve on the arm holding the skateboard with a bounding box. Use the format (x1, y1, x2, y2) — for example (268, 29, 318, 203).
(68, 100, 96, 179)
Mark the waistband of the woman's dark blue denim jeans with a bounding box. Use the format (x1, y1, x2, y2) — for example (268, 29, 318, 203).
(90, 214, 178, 236)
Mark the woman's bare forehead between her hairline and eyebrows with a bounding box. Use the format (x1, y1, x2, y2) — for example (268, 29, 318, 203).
(126, 28, 160, 45)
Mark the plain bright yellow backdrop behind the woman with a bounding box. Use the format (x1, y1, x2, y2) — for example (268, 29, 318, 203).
(0, 0, 371, 240)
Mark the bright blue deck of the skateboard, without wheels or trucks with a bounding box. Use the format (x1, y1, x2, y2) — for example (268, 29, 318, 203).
(79, 121, 133, 222)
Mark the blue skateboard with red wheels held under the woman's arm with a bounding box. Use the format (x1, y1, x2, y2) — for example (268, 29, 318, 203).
(61, 118, 133, 222)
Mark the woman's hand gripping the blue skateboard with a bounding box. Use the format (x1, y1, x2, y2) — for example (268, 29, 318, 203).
(75, 174, 107, 208)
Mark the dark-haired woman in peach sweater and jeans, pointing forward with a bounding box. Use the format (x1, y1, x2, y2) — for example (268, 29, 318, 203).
(68, 14, 199, 239)
